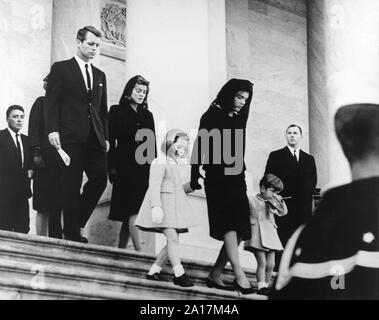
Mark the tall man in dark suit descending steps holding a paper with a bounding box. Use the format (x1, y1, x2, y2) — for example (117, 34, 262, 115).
(45, 26, 109, 242)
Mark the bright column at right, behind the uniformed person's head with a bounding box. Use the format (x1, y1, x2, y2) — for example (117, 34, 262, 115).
(307, 0, 379, 188)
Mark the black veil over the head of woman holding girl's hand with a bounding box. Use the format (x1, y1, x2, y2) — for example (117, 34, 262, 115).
(213, 79, 253, 121)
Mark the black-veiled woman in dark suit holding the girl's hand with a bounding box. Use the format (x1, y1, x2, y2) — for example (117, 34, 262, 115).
(191, 79, 253, 293)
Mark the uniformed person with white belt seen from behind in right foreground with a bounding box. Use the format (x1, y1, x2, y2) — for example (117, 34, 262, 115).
(271, 103, 379, 300)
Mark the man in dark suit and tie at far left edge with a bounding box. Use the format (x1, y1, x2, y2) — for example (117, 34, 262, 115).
(0, 105, 32, 233)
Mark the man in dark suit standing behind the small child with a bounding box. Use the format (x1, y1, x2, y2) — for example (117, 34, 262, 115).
(265, 124, 317, 246)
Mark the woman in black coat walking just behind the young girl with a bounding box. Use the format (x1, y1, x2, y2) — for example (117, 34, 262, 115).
(108, 75, 156, 251)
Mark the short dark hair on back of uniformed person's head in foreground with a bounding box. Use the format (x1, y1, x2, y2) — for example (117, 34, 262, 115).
(334, 103, 379, 163)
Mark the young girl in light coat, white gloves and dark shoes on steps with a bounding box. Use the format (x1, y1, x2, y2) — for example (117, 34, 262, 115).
(135, 129, 198, 287)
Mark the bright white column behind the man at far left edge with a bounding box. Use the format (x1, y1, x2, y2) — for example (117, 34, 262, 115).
(0, 0, 51, 133)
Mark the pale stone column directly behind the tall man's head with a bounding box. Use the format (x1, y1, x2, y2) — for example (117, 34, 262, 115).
(51, 0, 100, 64)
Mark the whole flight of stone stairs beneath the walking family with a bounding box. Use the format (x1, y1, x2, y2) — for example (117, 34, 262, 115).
(0, 231, 266, 300)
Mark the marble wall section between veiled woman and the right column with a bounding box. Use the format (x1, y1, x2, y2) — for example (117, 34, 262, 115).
(226, 0, 309, 190)
